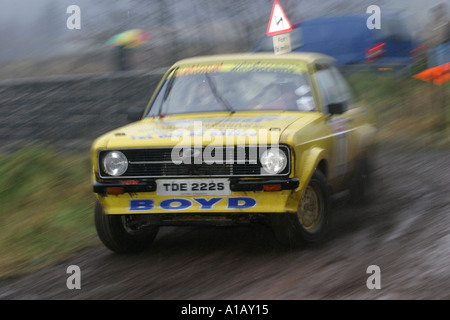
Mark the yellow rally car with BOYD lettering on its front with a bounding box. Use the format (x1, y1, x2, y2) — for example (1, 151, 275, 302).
(91, 53, 376, 253)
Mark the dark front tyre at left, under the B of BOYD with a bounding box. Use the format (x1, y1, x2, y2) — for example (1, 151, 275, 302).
(94, 201, 159, 253)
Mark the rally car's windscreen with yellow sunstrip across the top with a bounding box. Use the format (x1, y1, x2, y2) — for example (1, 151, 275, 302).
(148, 61, 315, 116)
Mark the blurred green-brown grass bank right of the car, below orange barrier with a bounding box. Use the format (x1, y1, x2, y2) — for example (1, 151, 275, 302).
(348, 72, 450, 150)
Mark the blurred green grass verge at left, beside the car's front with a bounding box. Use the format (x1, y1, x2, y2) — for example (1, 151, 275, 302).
(0, 147, 97, 279)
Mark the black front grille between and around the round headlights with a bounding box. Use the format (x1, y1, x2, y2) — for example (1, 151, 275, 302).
(99, 145, 291, 179)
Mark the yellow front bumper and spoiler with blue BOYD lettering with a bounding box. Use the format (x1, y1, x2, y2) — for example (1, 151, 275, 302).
(94, 178, 299, 215)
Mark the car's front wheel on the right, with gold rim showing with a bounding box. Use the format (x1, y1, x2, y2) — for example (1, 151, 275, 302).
(272, 170, 329, 247)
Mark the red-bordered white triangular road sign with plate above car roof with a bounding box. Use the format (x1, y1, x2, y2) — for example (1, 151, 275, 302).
(266, 0, 292, 54)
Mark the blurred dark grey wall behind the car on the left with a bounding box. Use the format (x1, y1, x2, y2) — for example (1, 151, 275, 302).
(0, 70, 164, 151)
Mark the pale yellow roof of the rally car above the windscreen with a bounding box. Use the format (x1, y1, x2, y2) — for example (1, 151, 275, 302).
(173, 52, 336, 67)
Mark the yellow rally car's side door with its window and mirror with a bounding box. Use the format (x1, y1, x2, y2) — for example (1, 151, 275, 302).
(315, 64, 355, 181)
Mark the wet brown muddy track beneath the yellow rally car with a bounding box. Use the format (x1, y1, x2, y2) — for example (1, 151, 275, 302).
(0, 146, 450, 300)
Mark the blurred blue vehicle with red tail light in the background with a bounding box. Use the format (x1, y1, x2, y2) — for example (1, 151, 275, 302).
(252, 13, 421, 70)
